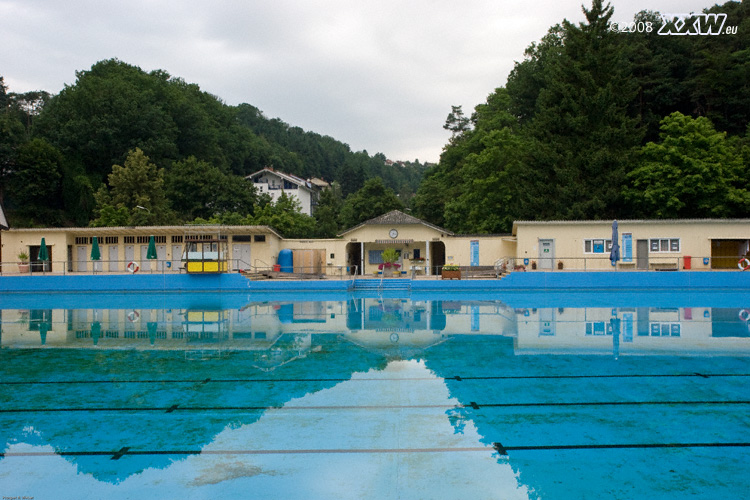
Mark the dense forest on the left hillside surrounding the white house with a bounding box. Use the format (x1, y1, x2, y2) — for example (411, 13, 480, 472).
(0, 59, 425, 237)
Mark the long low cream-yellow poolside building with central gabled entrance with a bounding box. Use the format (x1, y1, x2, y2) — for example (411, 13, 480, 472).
(0, 210, 750, 277)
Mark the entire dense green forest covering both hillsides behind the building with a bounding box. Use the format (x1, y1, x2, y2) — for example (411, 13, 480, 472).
(0, 0, 750, 237)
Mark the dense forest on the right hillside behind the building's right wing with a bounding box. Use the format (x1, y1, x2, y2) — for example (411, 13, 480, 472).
(414, 0, 750, 233)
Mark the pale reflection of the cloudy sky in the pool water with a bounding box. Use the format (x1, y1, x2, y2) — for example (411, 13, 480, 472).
(0, 361, 529, 499)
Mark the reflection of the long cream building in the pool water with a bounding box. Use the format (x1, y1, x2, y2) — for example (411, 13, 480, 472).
(1, 297, 750, 360)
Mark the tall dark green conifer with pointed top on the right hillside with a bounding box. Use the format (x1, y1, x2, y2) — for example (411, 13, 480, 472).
(517, 0, 642, 219)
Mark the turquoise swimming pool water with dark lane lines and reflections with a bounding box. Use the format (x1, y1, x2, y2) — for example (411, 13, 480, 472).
(0, 292, 750, 499)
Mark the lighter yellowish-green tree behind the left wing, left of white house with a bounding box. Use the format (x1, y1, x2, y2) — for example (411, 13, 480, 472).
(92, 148, 175, 226)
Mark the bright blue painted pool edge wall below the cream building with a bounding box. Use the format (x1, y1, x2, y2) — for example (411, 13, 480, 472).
(0, 271, 750, 293)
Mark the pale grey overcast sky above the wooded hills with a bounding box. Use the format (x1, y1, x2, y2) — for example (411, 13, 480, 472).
(0, 0, 723, 162)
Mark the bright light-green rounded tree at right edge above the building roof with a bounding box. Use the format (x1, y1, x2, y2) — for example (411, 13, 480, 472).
(626, 112, 750, 219)
